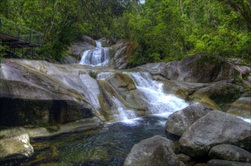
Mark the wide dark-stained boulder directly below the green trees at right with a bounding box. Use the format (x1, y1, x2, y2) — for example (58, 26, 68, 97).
(162, 55, 247, 83)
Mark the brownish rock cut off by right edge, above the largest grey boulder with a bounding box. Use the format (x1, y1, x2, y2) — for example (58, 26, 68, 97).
(227, 97, 251, 118)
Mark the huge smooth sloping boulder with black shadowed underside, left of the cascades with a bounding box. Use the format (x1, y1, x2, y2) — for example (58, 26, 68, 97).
(0, 60, 98, 126)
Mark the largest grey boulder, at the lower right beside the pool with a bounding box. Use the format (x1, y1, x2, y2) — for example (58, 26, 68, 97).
(179, 111, 251, 157)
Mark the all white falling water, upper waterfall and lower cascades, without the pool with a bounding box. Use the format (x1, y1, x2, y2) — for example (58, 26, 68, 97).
(80, 41, 188, 121)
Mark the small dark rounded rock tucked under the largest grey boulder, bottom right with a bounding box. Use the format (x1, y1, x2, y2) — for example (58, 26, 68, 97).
(209, 144, 251, 163)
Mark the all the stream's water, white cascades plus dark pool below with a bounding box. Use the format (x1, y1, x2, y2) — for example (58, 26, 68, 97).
(0, 39, 188, 166)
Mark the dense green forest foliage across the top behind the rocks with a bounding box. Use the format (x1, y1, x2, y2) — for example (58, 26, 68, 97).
(0, 0, 251, 65)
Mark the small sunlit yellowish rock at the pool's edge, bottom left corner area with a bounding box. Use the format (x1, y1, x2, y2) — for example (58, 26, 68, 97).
(0, 134, 34, 160)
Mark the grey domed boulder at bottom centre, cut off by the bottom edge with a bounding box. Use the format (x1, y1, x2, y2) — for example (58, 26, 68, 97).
(124, 136, 183, 166)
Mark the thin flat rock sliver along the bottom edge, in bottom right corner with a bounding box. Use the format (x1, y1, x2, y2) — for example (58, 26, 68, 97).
(207, 160, 251, 166)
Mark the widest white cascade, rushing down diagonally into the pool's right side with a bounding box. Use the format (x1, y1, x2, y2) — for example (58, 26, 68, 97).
(128, 72, 188, 117)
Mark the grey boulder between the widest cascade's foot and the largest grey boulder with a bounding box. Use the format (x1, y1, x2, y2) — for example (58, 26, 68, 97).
(166, 103, 210, 136)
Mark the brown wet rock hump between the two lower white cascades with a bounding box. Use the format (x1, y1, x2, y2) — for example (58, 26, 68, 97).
(98, 72, 146, 120)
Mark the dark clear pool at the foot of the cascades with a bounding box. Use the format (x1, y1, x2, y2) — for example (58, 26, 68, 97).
(3, 116, 173, 166)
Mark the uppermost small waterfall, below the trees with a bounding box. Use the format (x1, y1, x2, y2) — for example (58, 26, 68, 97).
(79, 41, 110, 66)
